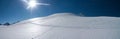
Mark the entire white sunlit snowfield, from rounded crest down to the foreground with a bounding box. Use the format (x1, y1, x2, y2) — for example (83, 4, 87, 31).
(0, 13, 120, 39)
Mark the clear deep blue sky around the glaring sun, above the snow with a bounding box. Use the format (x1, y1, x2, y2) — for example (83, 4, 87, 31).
(0, 0, 120, 23)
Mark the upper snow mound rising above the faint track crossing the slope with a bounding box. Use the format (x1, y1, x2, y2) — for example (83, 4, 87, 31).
(15, 13, 120, 28)
